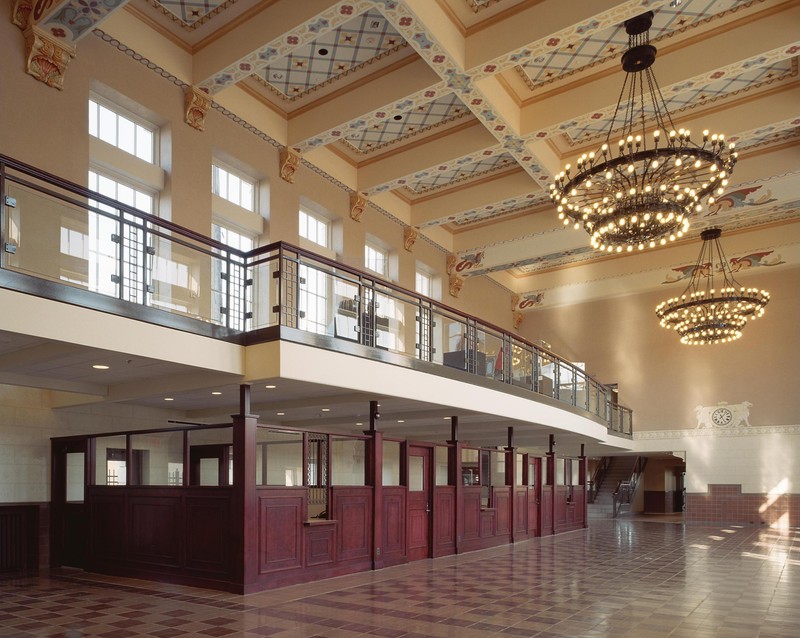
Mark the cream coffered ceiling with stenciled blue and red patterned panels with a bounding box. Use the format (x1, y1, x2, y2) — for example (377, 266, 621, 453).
(18, 0, 800, 308)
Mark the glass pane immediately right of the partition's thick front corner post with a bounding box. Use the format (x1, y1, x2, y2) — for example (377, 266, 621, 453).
(256, 428, 303, 487)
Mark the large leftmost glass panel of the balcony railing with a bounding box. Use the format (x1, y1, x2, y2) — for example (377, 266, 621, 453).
(3, 182, 121, 297)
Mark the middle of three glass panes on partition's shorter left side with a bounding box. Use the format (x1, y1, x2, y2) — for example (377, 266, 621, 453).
(131, 432, 183, 485)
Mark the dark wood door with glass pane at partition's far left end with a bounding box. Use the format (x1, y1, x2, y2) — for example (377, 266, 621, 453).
(50, 439, 89, 567)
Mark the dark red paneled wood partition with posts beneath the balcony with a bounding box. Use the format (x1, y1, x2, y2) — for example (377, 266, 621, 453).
(48, 414, 586, 593)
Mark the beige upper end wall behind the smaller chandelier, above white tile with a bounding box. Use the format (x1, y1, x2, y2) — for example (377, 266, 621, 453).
(522, 268, 800, 431)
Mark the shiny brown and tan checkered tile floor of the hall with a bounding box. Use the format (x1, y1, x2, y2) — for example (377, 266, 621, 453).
(0, 520, 800, 638)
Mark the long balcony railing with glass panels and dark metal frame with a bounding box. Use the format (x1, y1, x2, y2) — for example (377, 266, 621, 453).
(0, 155, 632, 435)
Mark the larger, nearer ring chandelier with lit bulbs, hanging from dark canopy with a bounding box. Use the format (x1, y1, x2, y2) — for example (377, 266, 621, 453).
(550, 11, 736, 252)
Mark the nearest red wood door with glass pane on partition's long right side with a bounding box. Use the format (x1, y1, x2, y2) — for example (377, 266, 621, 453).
(407, 445, 433, 560)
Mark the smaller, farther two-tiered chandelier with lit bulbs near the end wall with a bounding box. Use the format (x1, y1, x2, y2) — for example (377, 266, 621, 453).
(656, 228, 769, 345)
